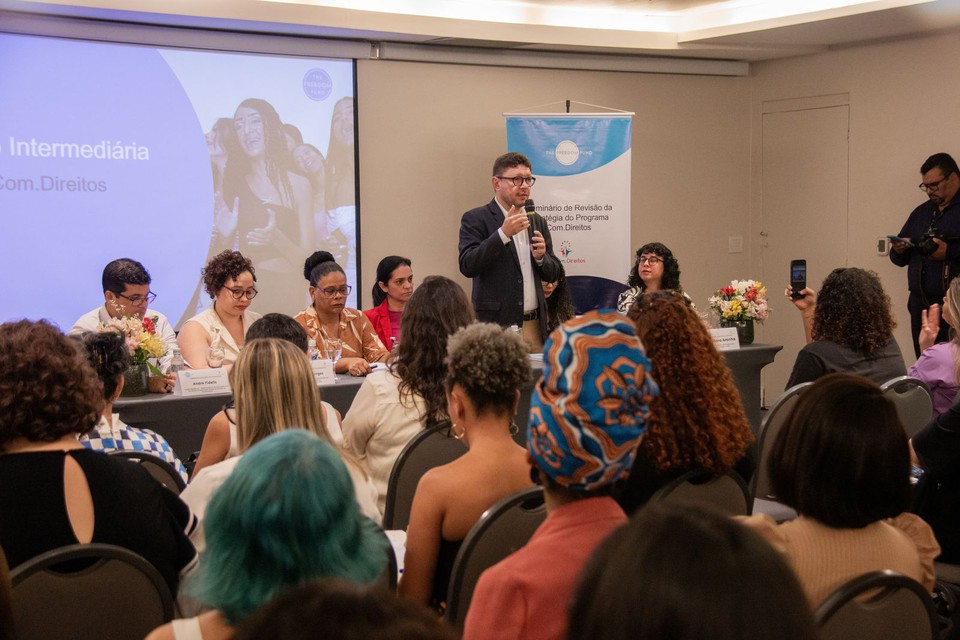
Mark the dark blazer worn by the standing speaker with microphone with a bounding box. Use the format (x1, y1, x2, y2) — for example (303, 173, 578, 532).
(460, 199, 563, 340)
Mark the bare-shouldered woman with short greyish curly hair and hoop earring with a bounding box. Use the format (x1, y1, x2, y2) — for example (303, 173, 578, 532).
(400, 324, 532, 610)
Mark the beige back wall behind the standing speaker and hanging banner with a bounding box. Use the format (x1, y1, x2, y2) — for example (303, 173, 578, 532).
(357, 60, 750, 307)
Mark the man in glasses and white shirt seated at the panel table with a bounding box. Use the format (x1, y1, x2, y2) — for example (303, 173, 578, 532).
(69, 258, 177, 393)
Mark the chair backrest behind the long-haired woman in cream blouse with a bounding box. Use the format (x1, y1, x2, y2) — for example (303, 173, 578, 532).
(383, 422, 467, 529)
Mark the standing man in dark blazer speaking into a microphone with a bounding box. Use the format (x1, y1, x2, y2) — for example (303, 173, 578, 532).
(460, 153, 562, 353)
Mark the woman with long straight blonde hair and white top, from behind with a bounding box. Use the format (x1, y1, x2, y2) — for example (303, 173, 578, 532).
(181, 338, 380, 550)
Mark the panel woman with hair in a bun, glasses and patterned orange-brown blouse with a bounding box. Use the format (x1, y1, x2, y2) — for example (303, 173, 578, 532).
(294, 251, 389, 376)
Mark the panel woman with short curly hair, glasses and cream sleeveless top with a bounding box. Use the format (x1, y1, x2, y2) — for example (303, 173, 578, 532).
(177, 250, 260, 369)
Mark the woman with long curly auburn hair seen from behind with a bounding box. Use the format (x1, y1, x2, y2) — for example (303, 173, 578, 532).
(619, 291, 756, 514)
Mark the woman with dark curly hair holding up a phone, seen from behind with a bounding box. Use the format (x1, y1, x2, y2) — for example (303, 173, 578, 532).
(786, 267, 907, 389)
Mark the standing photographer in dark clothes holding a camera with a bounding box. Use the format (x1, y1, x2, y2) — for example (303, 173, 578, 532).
(890, 153, 960, 357)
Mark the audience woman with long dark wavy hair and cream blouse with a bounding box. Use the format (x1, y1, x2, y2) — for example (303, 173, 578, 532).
(343, 276, 473, 511)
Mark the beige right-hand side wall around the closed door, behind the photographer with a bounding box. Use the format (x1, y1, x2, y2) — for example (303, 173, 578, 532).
(751, 34, 960, 370)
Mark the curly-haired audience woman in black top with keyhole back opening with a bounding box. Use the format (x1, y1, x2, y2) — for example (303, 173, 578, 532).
(0, 320, 197, 602)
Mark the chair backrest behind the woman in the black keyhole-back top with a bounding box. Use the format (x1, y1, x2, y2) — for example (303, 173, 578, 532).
(10, 543, 173, 640)
